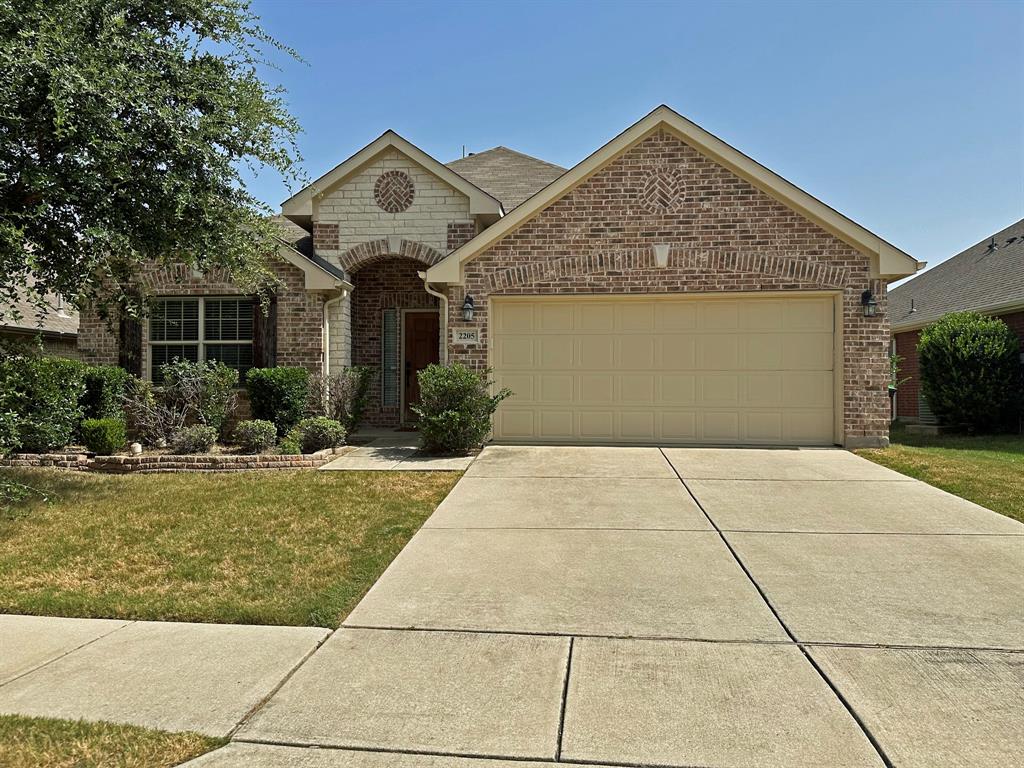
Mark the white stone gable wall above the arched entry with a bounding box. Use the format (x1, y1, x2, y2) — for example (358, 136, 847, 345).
(313, 147, 471, 263)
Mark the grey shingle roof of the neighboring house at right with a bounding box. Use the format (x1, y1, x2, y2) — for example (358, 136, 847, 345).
(889, 219, 1024, 331)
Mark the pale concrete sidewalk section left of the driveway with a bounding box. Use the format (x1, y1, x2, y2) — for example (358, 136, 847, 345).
(0, 615, 330, 737)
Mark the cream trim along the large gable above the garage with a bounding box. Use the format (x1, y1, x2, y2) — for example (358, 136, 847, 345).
(427, 105, 920, 284)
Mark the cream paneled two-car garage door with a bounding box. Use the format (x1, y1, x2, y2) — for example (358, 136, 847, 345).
(487, 291, 844, 445)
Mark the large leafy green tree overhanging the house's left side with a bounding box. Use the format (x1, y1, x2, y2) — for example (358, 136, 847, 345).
(0, 0, 298, 317)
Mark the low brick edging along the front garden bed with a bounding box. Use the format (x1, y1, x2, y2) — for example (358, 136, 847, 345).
(0, 447, 349, 474)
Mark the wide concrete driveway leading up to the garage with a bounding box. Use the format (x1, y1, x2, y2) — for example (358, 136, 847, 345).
(211, 446, 1024, 768)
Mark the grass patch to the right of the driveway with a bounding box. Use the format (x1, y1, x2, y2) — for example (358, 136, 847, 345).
(857, 427, 1024, 522)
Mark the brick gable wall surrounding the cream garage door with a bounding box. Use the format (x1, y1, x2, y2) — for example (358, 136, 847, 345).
(449, 131, 889, 448)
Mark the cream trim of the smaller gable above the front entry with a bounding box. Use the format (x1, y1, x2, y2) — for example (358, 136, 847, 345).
(281, 130, 502, 227)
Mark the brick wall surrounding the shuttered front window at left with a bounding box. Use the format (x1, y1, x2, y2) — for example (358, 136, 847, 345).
(78, 253, 324, 373)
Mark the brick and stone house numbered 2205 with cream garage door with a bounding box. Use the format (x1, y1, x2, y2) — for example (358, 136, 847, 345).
(80, 106, 919, 445)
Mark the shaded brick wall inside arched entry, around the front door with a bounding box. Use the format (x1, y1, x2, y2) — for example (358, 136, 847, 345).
(352, 259, 437, 426)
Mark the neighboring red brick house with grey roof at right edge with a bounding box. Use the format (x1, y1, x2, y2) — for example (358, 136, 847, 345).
(889, 219, 1024, 422)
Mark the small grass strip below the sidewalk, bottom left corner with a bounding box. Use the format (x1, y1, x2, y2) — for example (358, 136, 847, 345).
(0, 715, 224, 768)
